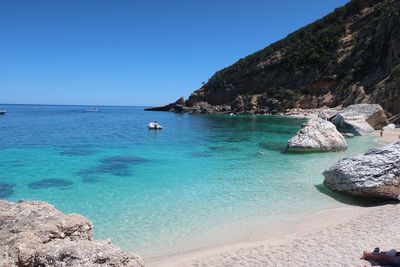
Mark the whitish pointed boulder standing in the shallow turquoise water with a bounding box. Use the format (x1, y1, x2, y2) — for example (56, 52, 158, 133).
(287, 118, 347, 152)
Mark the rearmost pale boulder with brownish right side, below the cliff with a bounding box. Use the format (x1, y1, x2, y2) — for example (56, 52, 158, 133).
(342, 104, 389, 130)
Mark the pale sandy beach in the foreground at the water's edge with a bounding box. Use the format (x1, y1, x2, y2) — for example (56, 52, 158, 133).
(151, 204, 400, 266)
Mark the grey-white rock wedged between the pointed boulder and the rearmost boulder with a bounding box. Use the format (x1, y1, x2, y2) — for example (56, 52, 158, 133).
(332, 112, 374, 135)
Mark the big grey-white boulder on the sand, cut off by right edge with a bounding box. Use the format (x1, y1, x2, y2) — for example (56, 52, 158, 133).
(323, 141, 400, 199)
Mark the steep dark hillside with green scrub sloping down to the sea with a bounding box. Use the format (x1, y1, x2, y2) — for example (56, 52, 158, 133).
(149, 0, 400, 114)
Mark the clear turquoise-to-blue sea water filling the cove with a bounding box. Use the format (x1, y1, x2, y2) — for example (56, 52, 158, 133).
(0, 105, 374, 257)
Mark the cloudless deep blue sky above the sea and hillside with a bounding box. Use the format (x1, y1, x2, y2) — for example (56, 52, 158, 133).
(0, 0, 347, 105)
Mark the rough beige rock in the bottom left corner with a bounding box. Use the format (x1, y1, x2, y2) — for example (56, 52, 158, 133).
(0, 201, 143, 267)
